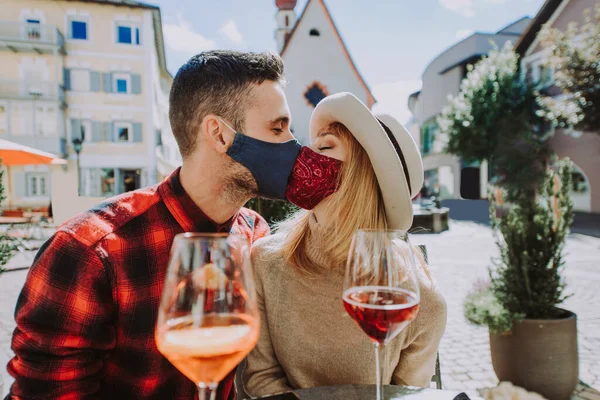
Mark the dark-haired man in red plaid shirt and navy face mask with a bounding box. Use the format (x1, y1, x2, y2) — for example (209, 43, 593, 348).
(7, 51, 299, 399)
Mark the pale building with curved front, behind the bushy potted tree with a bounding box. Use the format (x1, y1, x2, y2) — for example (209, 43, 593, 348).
(408, 18, 531, 199)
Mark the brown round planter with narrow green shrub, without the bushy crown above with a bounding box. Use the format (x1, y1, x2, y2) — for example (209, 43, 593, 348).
(464, 160, 579, 400)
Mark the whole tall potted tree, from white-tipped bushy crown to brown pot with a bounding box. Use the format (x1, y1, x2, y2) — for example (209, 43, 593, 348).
(437, 43, 578, 400)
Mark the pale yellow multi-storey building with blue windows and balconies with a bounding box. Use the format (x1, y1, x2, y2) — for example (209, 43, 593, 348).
(0, 0, 172, 207)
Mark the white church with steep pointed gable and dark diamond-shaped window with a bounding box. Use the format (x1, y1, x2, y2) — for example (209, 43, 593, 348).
(275, 0, 375, 144)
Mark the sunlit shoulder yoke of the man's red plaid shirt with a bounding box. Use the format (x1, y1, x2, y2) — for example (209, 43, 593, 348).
(57, 185, 161, 246)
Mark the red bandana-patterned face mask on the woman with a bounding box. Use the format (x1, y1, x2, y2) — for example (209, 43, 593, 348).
(285, 147, 342, 210)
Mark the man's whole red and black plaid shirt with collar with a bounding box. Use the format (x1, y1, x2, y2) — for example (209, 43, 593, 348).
(7, 170, 269, 399)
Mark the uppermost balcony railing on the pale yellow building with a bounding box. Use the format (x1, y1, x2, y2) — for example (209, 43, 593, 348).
(0, 21, 65, 51)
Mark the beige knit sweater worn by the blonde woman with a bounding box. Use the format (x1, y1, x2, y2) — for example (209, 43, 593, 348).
(242, 218, 446, 396)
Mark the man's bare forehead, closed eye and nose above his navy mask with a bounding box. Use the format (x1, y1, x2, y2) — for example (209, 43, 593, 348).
(242, 81, 294, 143)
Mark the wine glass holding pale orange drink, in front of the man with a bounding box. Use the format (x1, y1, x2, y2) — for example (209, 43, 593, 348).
(155, 233, 260, 400)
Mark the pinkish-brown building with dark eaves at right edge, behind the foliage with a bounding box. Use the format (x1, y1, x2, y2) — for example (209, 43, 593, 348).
(516, 0, 600, 214)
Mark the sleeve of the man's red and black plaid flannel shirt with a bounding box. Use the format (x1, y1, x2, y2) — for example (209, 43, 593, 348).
(7, 232, 115, 399)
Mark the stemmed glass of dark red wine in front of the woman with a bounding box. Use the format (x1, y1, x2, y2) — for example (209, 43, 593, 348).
(343, 229, 420, 400)
